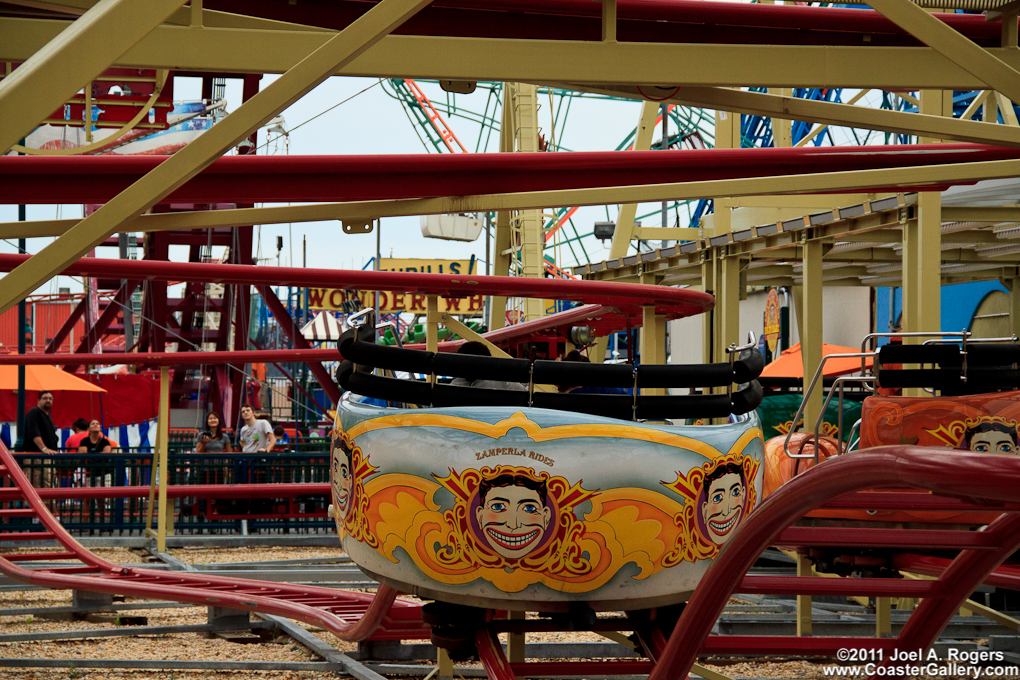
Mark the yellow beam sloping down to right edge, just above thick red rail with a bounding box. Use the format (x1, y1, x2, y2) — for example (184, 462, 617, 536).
(562, 85, 1020, 147)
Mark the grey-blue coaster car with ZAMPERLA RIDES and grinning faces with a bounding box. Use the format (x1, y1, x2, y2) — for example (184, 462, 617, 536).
(332, 328, 764, 612)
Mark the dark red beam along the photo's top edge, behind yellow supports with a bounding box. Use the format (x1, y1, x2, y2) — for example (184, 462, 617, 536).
(194, 0, 1001, 47)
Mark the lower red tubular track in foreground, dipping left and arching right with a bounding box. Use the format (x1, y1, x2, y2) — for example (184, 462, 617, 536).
(0, 444, 1020, 680)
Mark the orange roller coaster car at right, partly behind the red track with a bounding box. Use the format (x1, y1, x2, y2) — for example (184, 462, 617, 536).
(764, 333, 1020, 525)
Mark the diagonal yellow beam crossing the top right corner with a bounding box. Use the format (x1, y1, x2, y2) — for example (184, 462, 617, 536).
(867, 0, 1020, 101)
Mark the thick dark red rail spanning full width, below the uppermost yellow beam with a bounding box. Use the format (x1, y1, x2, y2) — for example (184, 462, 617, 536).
(0, 144, 1020, 204)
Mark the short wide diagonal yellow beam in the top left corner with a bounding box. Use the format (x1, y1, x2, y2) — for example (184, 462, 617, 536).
(0, 0, 184, 154)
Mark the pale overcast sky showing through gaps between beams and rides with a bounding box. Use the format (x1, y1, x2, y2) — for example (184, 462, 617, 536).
(0, 76, 877, 293)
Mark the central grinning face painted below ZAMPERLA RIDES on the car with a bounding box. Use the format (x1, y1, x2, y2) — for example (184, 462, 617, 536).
(475, 474, 552, 559)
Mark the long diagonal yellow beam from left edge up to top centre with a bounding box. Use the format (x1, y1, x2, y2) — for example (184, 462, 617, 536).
(0, 0, 429, 313)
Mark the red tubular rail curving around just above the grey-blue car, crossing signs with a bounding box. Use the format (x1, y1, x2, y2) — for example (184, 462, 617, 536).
(0, 253, 715, 320)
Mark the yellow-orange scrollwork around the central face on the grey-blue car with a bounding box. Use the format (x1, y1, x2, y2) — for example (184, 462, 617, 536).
(366, 465, 682, 592)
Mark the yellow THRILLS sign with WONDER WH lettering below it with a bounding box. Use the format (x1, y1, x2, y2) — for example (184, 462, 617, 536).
(308, 258, 486, 315)
